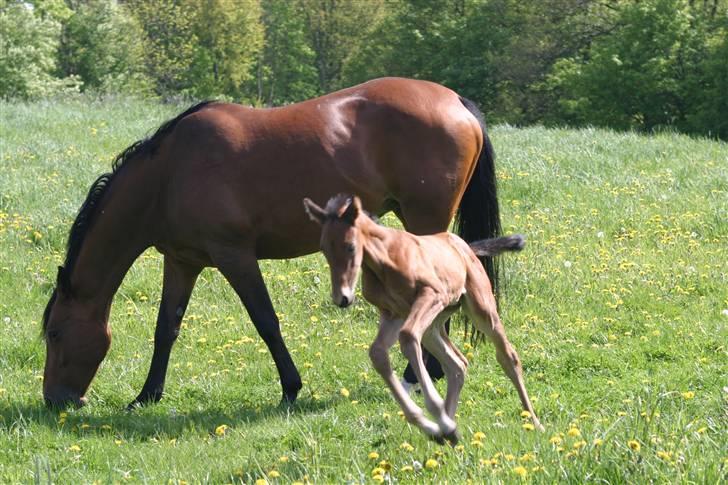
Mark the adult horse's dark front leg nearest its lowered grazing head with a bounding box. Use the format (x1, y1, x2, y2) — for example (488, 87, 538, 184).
(128, 256, 200, 409)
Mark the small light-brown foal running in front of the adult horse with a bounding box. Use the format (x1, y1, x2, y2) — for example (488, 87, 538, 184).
(303, 195, 543, 443)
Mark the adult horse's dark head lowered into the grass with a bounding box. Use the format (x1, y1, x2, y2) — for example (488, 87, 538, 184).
(43, 268, 111, 407)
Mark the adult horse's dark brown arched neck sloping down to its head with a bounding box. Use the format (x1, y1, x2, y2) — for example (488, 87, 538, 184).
(71, 164, 159, 308)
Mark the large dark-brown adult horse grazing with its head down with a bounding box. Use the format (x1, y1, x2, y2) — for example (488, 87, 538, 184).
(43, 78, 500, 405)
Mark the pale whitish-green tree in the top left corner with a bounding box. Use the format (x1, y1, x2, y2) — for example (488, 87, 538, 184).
(0, 1, 78, 98)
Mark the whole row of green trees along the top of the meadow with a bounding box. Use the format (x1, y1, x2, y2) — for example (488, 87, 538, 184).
(0, 0, 728, 139)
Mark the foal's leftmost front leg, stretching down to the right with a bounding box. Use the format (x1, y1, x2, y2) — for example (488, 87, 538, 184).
(369, 313, 440, 440)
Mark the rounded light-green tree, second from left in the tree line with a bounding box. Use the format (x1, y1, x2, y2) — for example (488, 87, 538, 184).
(59, 0, 151, 95)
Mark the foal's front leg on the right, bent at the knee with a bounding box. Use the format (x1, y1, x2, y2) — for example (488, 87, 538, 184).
(399, 293, 457, 442)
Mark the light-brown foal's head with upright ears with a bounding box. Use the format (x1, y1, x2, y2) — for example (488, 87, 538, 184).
(303, 194, 364, 308)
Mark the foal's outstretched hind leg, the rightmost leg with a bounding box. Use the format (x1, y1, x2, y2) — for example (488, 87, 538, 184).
(465, 282, 543, 431)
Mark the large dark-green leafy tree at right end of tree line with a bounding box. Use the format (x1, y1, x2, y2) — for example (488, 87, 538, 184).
(550, 0, 726, 137)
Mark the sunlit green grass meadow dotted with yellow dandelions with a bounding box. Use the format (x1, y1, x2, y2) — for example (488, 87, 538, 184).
(0, 99, 728, 483)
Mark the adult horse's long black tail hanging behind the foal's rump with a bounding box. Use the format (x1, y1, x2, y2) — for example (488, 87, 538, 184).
(455, 97, 501, 301)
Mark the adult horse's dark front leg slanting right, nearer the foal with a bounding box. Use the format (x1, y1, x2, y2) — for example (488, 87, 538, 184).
(213, 248, 302, 403)
